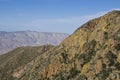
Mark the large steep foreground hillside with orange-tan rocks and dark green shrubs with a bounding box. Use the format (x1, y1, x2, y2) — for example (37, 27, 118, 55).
(0, 10, 120, 80)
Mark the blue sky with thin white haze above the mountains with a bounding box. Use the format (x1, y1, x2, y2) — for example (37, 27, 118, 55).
(0, 0, 120, 34)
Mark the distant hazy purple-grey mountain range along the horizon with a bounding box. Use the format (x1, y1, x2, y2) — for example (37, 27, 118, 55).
(0, 31, 68, 54)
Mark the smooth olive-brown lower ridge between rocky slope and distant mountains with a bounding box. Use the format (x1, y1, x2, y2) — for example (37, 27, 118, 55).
(0, 45, 53, 80)
